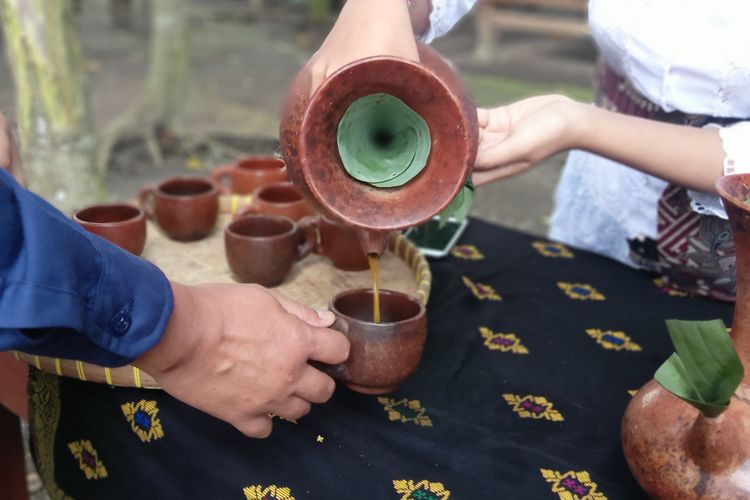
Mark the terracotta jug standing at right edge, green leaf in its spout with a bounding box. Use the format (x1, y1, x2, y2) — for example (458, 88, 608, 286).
(622, 175, 750, 500)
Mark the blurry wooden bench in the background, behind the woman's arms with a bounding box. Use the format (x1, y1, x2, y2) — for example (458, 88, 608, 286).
(474, 0, 589, 61)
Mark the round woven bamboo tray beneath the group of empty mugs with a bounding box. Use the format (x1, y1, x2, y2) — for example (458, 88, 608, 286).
(14, 195, 432, 389)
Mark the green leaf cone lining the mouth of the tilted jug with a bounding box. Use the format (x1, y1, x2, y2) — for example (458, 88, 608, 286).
(336, 94, 432, 188)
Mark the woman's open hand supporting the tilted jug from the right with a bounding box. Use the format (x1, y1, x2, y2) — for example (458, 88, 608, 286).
(473, 95, 586, 185)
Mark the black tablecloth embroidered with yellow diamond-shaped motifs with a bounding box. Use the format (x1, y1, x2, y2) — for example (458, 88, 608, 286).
(30, 220, 732, 500)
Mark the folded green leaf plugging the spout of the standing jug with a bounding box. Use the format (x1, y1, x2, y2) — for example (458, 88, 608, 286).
(654, 320, 745, 417)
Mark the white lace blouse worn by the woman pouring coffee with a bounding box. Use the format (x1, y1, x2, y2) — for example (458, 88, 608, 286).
(426, 0, 750, 265)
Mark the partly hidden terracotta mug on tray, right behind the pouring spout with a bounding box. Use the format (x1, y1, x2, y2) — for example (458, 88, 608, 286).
(300, 215, 370, 271)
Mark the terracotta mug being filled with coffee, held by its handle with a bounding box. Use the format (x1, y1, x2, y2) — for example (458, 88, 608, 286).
(316, 288, 427, 394)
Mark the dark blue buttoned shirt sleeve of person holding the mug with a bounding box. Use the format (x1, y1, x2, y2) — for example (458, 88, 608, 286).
(0, 169, 174, 366)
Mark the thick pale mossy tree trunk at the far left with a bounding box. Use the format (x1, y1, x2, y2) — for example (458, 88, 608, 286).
(0, 0, 106, 212)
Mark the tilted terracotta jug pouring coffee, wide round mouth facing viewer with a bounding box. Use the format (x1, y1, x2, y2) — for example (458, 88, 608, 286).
(280, 45, 478, 254)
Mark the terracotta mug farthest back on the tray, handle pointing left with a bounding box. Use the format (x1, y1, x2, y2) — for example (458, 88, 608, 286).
(211, 156, 289, 194)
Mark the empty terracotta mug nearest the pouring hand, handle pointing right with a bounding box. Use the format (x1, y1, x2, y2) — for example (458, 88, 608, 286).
(224, 214, 317, 287)
